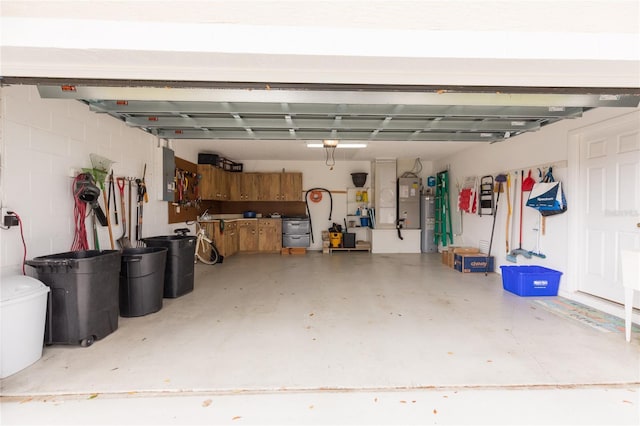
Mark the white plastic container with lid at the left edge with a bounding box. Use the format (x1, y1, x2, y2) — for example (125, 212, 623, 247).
(0, 275, 49, 378)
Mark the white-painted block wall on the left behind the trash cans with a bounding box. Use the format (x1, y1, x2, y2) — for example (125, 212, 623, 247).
(0, 86, 172, 275)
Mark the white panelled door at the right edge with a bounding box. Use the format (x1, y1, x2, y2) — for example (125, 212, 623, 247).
(580, 112, 640, 307)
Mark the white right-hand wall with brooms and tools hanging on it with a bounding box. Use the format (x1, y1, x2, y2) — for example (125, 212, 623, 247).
(434, 108, 635, 293)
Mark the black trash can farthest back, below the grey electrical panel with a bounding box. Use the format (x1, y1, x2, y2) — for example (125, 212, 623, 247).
(143, 235, 196, 298)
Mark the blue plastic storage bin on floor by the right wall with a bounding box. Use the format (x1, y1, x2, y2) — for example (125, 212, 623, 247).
(500, 265, 562, 296)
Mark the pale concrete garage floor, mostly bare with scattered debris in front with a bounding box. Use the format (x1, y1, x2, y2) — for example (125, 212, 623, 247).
(0, 252, 640, 425)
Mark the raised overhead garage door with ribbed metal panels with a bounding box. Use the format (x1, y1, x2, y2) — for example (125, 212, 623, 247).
(38, 83, 640, 150)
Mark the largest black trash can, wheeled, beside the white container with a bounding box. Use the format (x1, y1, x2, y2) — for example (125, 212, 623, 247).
(26, 250, 120, 346)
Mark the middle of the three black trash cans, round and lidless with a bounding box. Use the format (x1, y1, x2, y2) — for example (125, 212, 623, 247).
(120, 247, 168, 317)
